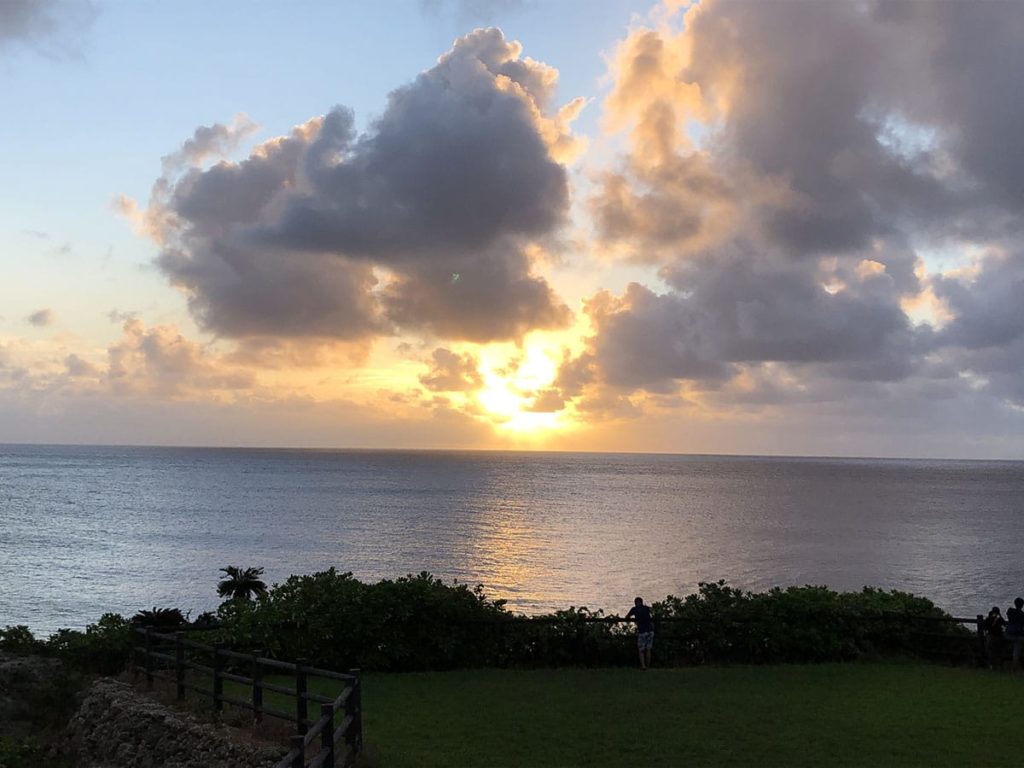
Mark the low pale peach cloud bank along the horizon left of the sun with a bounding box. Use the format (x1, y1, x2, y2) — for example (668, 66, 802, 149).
(0, 318, 499, 449)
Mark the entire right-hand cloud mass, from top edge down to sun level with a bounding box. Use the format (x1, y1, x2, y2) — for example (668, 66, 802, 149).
(556, 0, 1024, 421)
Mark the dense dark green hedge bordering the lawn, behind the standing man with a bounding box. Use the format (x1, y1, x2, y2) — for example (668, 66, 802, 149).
(207, 569, 972, 671)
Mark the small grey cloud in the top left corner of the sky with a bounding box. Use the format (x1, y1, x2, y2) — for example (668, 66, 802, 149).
(0, 0, 95, 55)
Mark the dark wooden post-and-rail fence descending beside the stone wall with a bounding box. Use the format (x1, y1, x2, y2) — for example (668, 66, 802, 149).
(133, 627, 362, 768)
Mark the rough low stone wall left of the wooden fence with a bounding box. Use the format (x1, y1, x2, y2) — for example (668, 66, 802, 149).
(67, 679, 287, 768)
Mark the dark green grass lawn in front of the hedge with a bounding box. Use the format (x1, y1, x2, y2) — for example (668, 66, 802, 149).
(226, 664, 1024, 768)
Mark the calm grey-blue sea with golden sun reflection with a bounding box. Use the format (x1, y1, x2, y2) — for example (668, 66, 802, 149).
(0, 445, 1024, 632)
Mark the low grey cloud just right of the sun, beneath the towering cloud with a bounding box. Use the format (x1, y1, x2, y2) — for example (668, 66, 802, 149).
(588, 251, 930, 391)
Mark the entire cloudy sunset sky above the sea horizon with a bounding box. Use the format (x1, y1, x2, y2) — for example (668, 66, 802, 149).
(0, 0, 1024, 459)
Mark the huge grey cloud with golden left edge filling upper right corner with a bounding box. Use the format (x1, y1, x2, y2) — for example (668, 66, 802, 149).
(594, 0, 1024, 256)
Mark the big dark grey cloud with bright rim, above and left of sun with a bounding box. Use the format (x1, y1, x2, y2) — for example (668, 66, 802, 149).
(147, 30, 569, 341)
